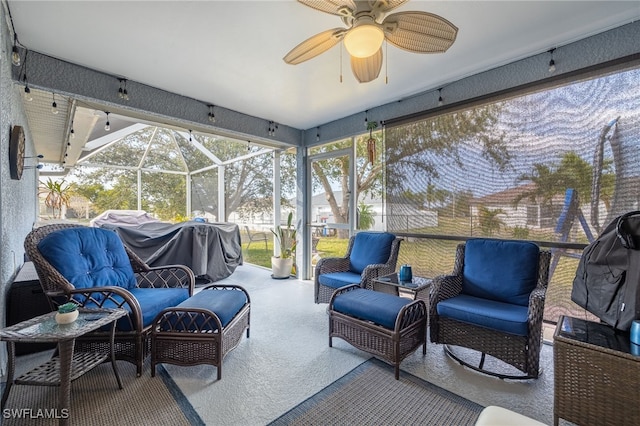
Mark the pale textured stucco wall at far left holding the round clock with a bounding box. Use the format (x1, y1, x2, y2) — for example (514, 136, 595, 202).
(0, 3, 37, 375)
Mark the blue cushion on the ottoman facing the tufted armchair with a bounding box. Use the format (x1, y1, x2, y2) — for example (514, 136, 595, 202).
(178, 290, 247, 331)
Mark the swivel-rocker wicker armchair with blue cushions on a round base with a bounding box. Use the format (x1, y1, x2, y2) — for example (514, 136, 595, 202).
(429, 239, 551, 379)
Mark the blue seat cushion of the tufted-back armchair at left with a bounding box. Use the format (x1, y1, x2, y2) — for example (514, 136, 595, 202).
(85, 288, 189, 331)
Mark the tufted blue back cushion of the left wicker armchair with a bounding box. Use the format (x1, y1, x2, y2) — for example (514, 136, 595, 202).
(38, 227, 136, 289)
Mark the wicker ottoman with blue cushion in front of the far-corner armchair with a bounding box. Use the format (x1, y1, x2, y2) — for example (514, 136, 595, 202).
(329, 285, 428, 380)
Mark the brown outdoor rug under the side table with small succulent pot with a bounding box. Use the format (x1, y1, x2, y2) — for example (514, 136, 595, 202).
(2, 362, 204, 426)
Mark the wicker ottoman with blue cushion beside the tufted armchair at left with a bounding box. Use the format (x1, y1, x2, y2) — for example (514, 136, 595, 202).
(151, 284, 251, 380)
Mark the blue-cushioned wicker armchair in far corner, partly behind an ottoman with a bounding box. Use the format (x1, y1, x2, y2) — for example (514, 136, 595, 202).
(315, 232, 402, 303)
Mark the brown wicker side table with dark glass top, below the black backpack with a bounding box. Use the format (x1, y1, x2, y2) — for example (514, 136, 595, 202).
(553, 316, 640, 426)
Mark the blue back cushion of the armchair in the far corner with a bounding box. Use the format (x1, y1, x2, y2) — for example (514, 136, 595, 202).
(349, 232, 396, 274)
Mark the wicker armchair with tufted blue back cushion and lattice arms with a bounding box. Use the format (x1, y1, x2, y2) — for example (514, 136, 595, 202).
(24, 224, 195, 376)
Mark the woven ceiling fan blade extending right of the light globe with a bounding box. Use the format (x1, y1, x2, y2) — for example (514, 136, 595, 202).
(382, 12, 458, 53)
